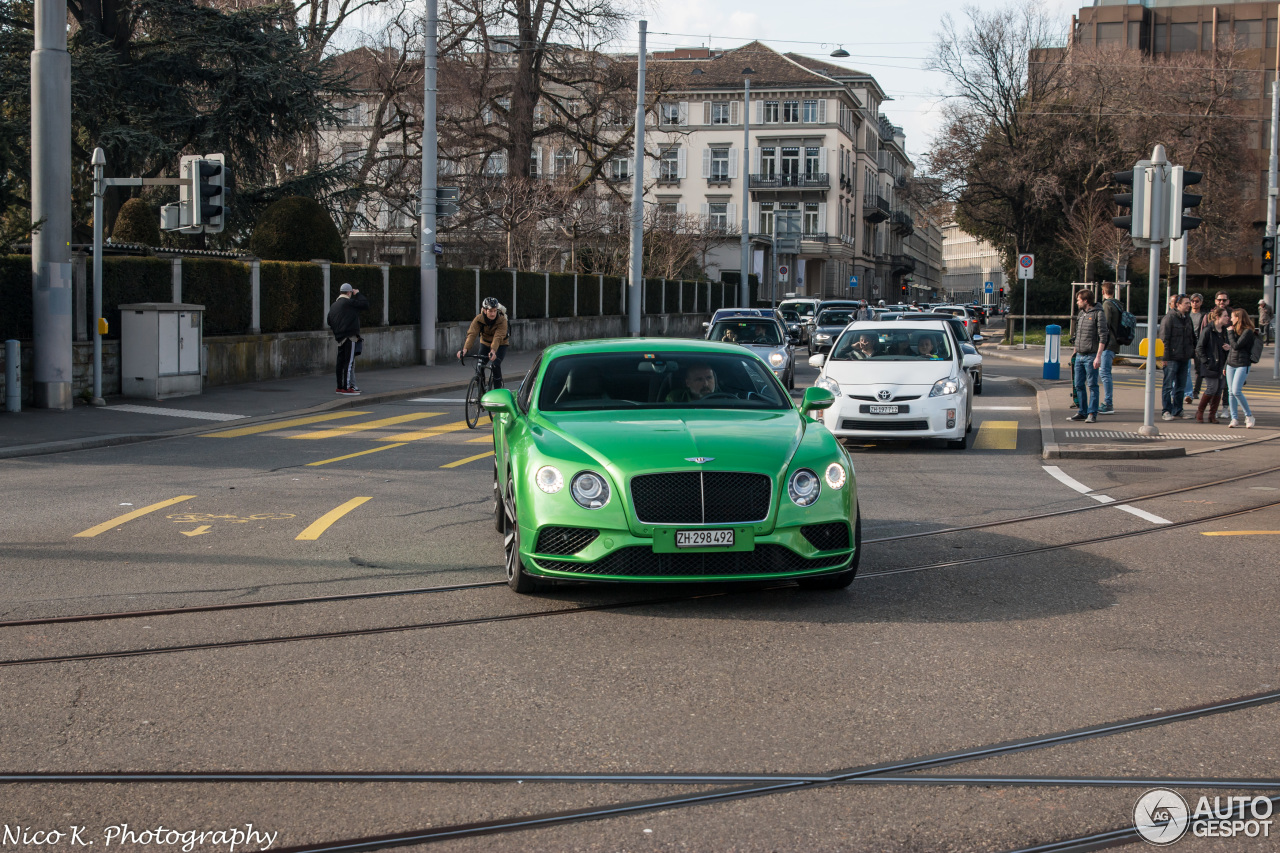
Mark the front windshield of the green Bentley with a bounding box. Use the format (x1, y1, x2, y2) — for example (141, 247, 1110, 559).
(538, 351, 791, 411)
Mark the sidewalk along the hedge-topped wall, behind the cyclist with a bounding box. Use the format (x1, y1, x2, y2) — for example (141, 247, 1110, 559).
(0, 352, 538, 459)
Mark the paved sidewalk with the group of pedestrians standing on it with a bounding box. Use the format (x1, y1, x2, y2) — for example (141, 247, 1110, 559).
(980, 343, 1280, 459)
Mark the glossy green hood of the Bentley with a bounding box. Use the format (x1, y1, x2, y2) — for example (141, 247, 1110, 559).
(543, 409, 805, 473)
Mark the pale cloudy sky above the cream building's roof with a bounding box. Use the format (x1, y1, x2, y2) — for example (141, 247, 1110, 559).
(625, 0, 1092, 163)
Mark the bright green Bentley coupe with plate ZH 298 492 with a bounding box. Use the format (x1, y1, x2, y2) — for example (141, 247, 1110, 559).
(483, 338, 861, 593)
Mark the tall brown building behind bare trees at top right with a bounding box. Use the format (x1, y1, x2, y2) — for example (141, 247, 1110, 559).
(1070, 0, 1277, 287)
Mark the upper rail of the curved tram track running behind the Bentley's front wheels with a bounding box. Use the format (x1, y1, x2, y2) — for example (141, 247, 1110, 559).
(0, 465, 1280, 629)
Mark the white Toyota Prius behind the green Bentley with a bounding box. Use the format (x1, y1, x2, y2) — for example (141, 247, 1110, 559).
(809, 320, 977, 450)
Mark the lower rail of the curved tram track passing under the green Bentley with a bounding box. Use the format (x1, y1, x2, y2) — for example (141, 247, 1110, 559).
(0, 501, 1280, 667)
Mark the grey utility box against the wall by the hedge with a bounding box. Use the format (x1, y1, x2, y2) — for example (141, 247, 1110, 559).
(120, 302, 205, 400)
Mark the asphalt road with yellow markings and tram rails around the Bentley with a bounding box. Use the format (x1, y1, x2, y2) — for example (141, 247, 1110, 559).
(0, 340, 1280, 850)
